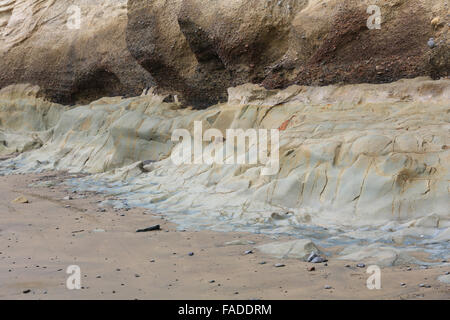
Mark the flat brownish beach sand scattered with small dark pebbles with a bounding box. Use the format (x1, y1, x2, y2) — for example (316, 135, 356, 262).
(0, 173, 450, 299)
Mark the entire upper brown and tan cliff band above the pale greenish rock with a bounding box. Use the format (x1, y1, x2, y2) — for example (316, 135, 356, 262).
(0, 0, 450, 107)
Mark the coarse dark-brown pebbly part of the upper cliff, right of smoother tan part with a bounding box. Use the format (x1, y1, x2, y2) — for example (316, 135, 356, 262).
(118, 0, 450, 107)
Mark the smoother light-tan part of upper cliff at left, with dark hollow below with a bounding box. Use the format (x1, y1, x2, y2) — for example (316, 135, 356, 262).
(0, 0, 152, 104)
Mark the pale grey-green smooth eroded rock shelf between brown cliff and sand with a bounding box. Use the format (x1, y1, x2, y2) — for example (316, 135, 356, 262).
(0, 78, 450, 264)
